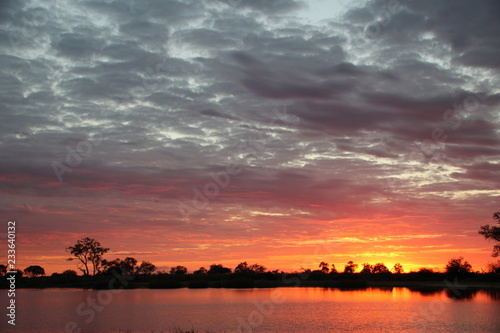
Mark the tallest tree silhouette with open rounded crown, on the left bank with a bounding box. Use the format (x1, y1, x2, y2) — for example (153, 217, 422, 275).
(66, 237, 109, 276)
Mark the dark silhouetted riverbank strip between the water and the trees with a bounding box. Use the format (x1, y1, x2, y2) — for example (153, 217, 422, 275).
(0, 273, 500, 290)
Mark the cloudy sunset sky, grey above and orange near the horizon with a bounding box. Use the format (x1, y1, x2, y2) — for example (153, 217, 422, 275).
(0, 0, 500, 274)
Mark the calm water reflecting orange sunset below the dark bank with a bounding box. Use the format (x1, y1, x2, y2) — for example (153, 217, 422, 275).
(0, 288, 500, 333)
